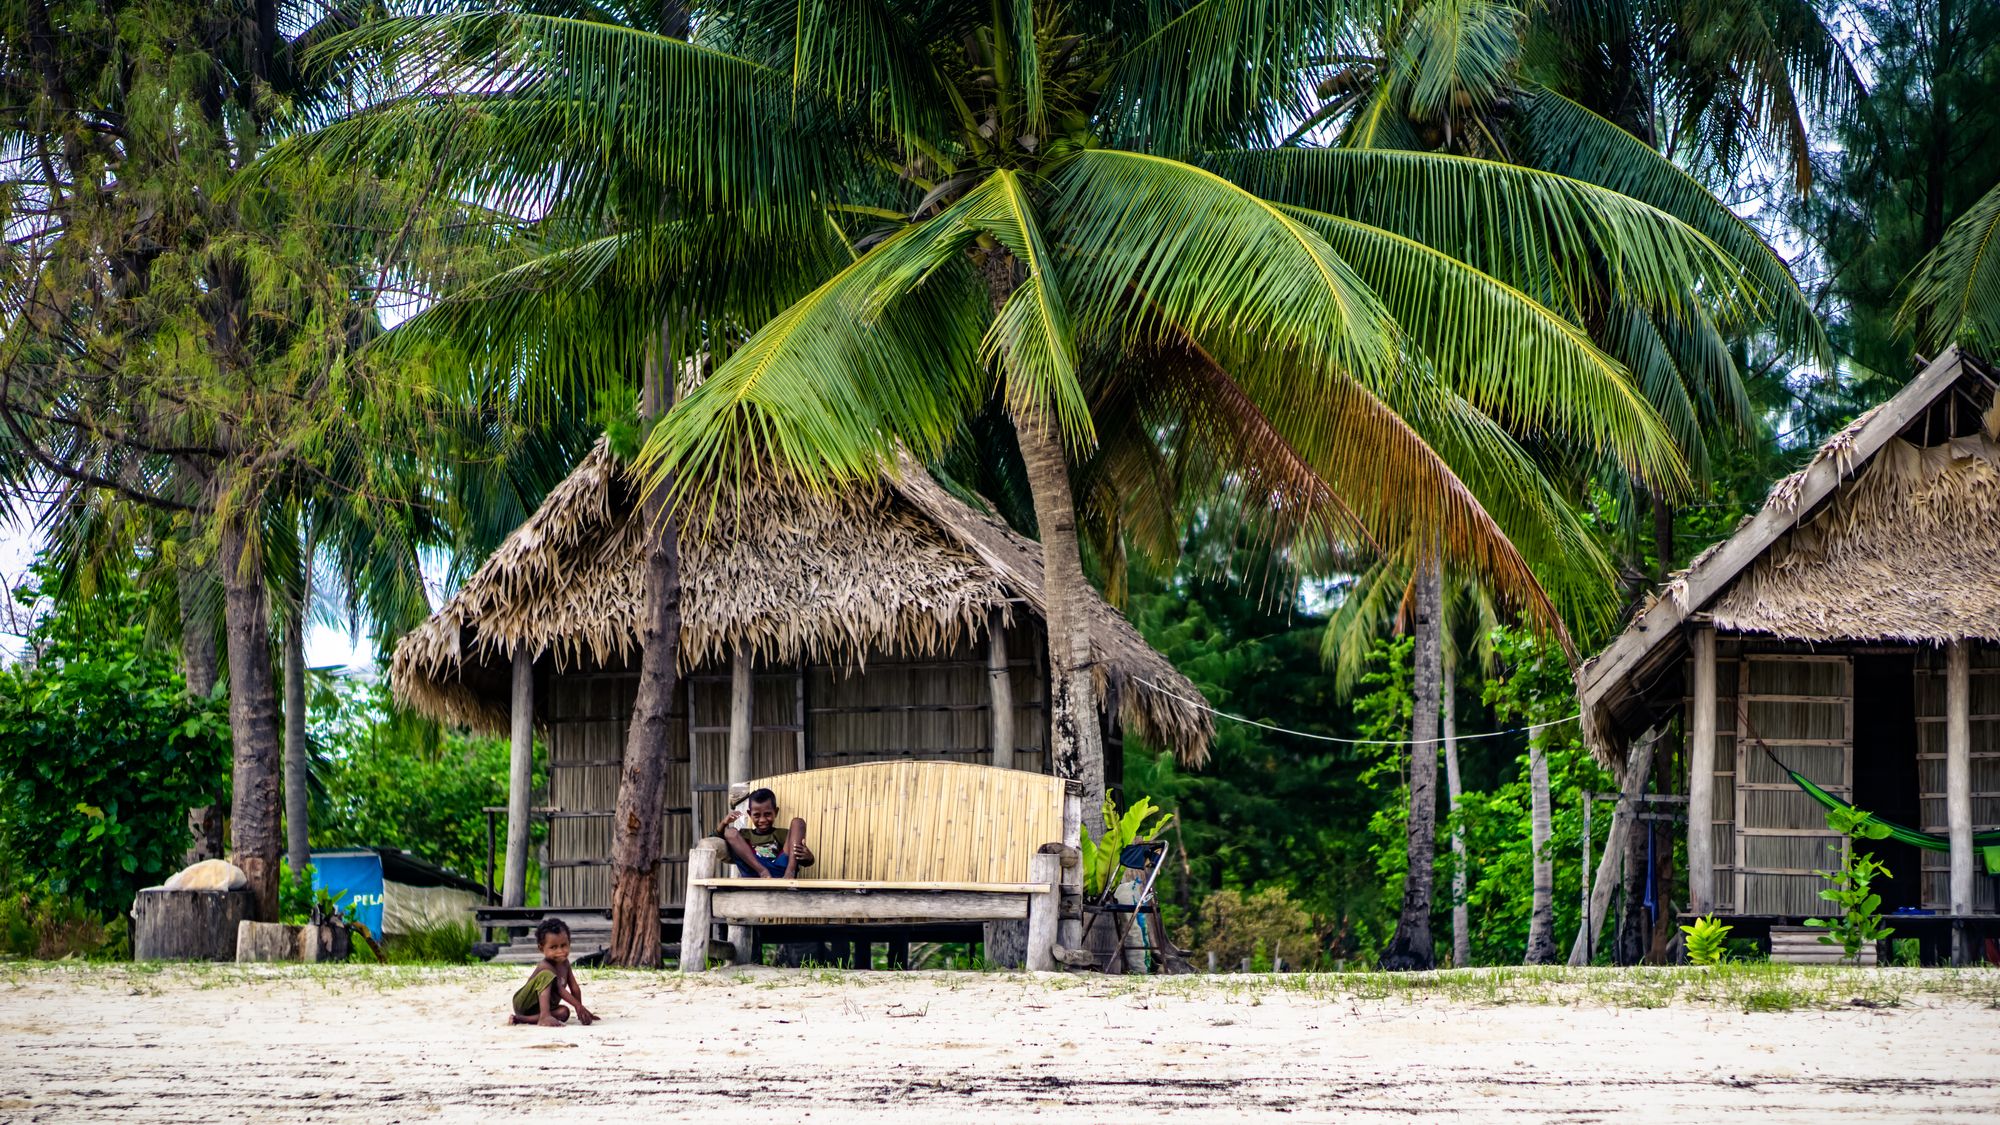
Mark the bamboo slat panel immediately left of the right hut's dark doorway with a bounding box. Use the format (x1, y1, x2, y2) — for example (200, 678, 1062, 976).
(1732, 653, 1854, 917)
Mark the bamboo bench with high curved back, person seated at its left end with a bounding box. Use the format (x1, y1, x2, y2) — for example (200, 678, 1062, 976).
(680, 761, 1082, 973)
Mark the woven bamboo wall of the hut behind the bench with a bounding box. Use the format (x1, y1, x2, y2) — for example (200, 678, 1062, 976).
(538, 625, 1060, 909)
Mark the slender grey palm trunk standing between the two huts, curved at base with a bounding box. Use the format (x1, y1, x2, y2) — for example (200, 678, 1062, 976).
(1382, 558, 1444, 971)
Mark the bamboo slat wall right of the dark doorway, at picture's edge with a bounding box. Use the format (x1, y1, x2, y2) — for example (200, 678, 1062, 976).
(1916, 645, 2000, 913)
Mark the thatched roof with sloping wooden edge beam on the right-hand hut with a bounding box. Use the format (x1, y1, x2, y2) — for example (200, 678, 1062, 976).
(1576, 350, 2000, 761)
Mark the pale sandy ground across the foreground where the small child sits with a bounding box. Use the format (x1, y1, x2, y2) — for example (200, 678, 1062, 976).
(0, 963, 2000, 1125)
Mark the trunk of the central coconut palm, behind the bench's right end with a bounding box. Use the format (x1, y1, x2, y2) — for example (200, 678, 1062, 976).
(986, 250, 1106, 835)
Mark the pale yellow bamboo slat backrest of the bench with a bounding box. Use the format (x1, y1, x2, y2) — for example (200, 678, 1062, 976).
(748, 761, 1066, 883)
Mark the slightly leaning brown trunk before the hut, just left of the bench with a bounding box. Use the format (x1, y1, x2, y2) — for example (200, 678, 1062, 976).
(606, 324, 684, 967)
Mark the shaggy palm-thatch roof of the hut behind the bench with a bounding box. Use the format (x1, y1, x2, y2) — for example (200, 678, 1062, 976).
(390, 440, 1212, 763)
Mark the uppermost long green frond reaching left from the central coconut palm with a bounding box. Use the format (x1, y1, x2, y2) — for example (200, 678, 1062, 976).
(268, 10, 828, 220)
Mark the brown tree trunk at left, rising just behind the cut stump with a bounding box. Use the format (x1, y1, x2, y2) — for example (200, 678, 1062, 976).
(220, 510, 280, 921)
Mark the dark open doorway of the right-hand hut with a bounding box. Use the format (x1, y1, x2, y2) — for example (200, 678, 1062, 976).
(1854, 653, 1924, 913)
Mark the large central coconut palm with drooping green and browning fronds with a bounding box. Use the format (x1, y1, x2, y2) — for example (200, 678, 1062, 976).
(292, 0, 1816, 964)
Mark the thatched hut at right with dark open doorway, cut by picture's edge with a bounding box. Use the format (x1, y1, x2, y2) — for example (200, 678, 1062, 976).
(1578, 350, 2000, 944)
